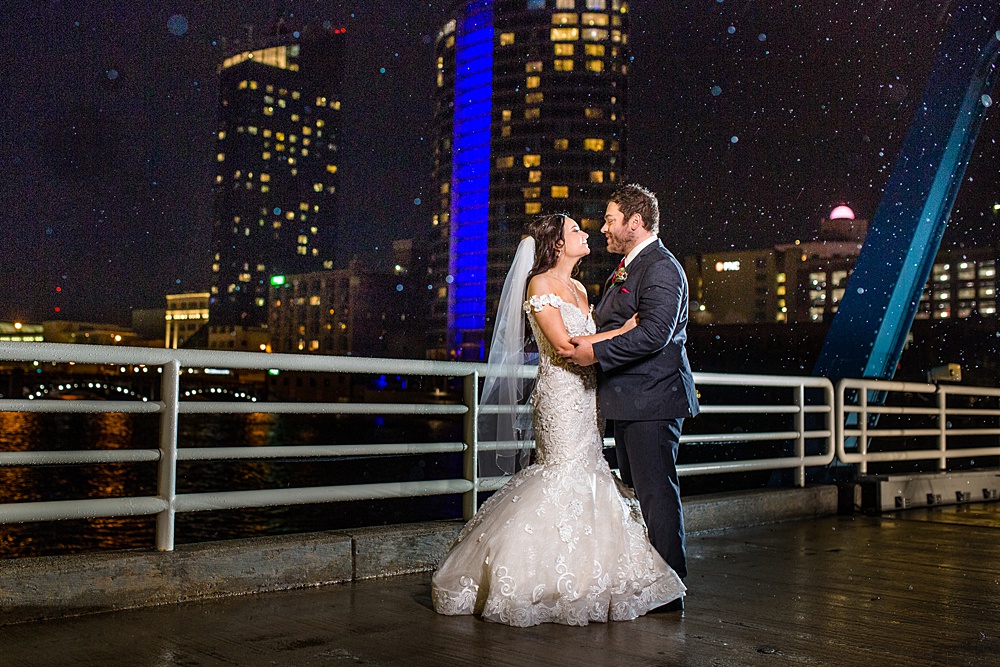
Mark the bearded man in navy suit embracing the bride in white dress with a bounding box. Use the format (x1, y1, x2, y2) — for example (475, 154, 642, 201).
(560, 184, 698, 611)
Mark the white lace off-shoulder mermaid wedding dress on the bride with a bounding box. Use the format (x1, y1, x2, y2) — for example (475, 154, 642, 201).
(431, 295, 685, 627)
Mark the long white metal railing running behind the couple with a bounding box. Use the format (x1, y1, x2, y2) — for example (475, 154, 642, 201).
(0, 343, 834, 551)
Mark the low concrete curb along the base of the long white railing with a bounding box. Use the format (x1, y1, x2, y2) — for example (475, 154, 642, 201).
(0, 485, 837, 626)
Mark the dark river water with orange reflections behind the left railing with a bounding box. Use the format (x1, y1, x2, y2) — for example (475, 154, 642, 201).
(0, 413, 461, 558)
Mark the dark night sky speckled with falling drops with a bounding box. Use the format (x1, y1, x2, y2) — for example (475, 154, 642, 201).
(0, 0, 1000, 324)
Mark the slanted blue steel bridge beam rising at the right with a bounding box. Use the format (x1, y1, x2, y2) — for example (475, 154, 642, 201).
(813, 0, 1000, 383)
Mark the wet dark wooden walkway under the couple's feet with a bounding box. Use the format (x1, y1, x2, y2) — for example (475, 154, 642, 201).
(0, 503, 1000, 667)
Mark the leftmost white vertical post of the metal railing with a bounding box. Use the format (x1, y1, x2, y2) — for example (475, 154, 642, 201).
(156, 359, 181, 551)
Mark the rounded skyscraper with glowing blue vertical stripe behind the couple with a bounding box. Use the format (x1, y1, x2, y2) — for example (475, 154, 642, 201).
(429, 0, 628, 360)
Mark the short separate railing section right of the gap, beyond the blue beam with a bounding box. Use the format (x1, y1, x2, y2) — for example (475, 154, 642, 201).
(836, 379, 1000, 474)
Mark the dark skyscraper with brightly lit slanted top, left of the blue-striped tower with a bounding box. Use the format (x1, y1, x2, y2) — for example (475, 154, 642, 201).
(210, 21, 345, 327)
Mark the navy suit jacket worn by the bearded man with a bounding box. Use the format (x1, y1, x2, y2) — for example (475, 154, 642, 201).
(594, 239, 699, 421)
